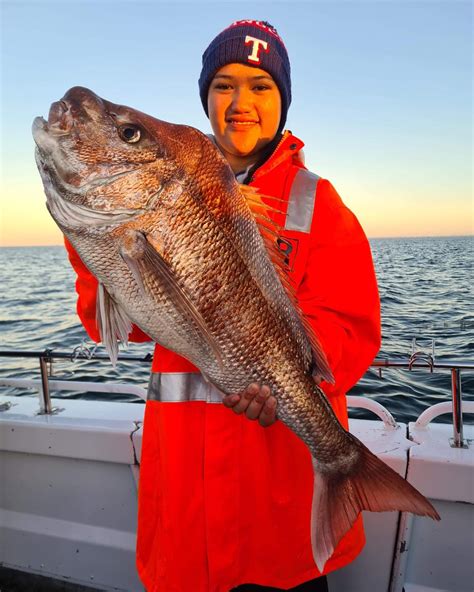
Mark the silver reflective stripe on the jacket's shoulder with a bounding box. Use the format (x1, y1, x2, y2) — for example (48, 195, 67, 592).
(285, 169, 319, 232)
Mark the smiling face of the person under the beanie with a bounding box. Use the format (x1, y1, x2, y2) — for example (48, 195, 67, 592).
(207, 64, 281, 172)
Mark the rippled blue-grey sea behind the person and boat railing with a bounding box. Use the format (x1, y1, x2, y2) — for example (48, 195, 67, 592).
(0, 237, 474, 422)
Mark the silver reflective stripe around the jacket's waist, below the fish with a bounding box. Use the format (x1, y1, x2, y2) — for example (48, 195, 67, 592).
(148, 372, 223, 403)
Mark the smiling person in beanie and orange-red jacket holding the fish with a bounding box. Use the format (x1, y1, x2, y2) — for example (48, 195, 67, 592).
(64, 21, 380, 592)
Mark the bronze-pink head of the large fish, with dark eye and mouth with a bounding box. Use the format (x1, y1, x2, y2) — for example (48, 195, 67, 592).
(33, 86, 201, 234)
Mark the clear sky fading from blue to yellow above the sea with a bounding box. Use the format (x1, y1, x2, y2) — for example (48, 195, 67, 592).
(0, 0, 474, 246)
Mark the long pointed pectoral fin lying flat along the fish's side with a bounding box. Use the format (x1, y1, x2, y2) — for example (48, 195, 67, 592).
(120, 231, 222, 365)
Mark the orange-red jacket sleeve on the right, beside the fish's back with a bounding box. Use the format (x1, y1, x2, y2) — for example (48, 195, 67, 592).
(297, 179, 381, 397)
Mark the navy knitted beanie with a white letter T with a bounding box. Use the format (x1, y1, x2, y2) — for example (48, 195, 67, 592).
(199, 20, 291, 131)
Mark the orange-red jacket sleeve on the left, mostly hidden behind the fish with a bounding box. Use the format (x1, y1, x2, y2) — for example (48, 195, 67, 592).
(64, 238, 151, 343)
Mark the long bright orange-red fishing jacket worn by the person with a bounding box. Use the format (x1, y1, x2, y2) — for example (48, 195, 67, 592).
(66, 132, 380, 592)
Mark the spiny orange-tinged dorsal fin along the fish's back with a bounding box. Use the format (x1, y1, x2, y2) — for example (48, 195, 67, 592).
(239, 185, 334, 384)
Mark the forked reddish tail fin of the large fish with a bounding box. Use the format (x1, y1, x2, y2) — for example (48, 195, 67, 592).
(311, 442, 440, 572)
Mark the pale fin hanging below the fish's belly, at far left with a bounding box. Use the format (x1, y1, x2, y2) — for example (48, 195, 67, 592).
(96, 282, 132, 367)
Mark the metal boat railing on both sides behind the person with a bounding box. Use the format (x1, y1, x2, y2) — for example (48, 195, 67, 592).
(0, 341, 474, 448)
